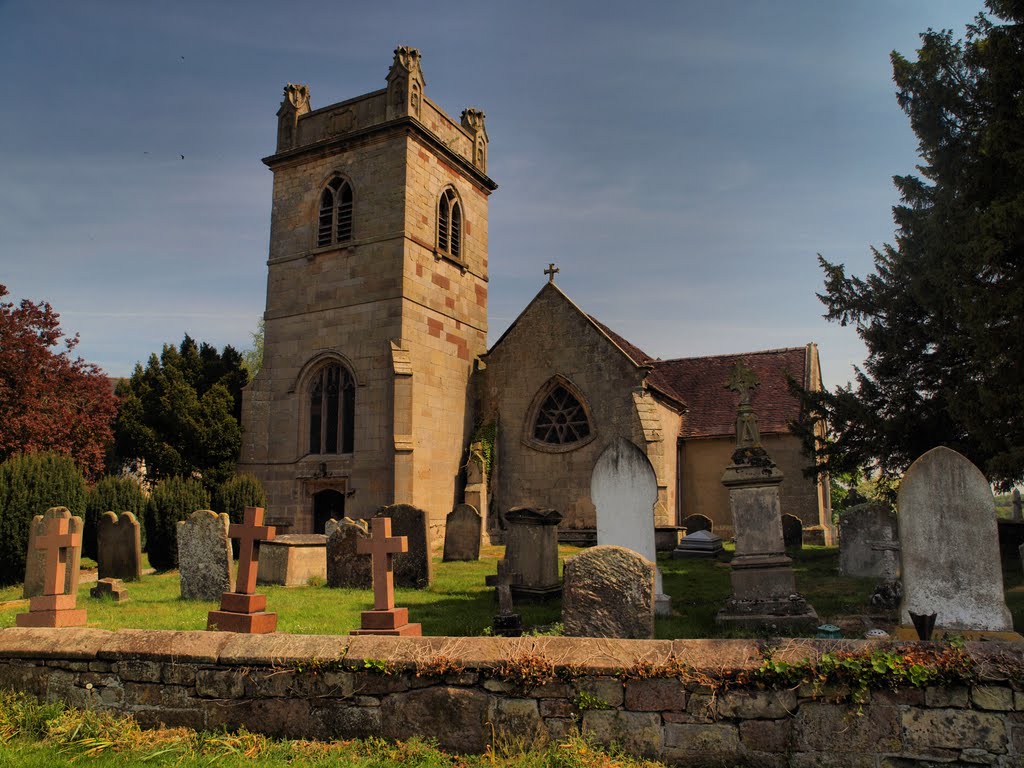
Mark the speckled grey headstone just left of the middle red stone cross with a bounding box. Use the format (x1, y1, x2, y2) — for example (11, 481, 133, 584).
(178, 509, 234, 600)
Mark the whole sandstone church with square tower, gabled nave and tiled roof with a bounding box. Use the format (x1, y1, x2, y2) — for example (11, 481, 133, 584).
(240, 46, 833, 543)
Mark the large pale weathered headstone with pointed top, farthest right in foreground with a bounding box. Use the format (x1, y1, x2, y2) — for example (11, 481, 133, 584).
(896, 446, 1013, 632)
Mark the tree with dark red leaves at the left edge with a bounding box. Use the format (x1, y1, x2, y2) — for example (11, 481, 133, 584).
(0, 285, 117, 478)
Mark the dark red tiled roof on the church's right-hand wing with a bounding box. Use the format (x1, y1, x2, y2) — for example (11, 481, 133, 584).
(649, 344, 814, 438)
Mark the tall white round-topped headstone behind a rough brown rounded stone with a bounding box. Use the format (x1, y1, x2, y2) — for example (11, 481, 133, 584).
(590, 437, 672, 615)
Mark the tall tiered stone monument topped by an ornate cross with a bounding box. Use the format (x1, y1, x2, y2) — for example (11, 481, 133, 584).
(716, 360, 817, 628)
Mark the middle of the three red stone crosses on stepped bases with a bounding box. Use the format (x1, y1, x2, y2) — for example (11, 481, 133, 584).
(206, 507, 278, 635)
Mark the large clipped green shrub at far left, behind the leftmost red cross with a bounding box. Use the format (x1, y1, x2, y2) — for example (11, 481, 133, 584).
(0, 454, 86, 586)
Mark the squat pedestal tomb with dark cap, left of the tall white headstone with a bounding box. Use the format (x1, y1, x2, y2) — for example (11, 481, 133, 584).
(505, 507, 562, 601)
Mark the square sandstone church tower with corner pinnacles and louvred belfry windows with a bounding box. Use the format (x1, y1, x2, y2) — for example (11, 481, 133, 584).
(239, 46, 497, 534)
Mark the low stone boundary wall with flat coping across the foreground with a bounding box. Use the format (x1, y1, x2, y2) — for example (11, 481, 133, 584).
(0, 629, 1024, 768)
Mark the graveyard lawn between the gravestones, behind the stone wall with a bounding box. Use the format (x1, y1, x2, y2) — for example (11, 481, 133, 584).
(8, 546, 1024, 638)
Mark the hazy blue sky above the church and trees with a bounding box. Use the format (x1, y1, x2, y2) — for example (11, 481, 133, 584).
(0, 0, 981, 385)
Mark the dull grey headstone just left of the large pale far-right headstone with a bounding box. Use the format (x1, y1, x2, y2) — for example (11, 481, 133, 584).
(839, 502, 899, 582)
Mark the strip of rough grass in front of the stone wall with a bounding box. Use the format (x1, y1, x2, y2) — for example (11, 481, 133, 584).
(0, 690, 663, 768)
